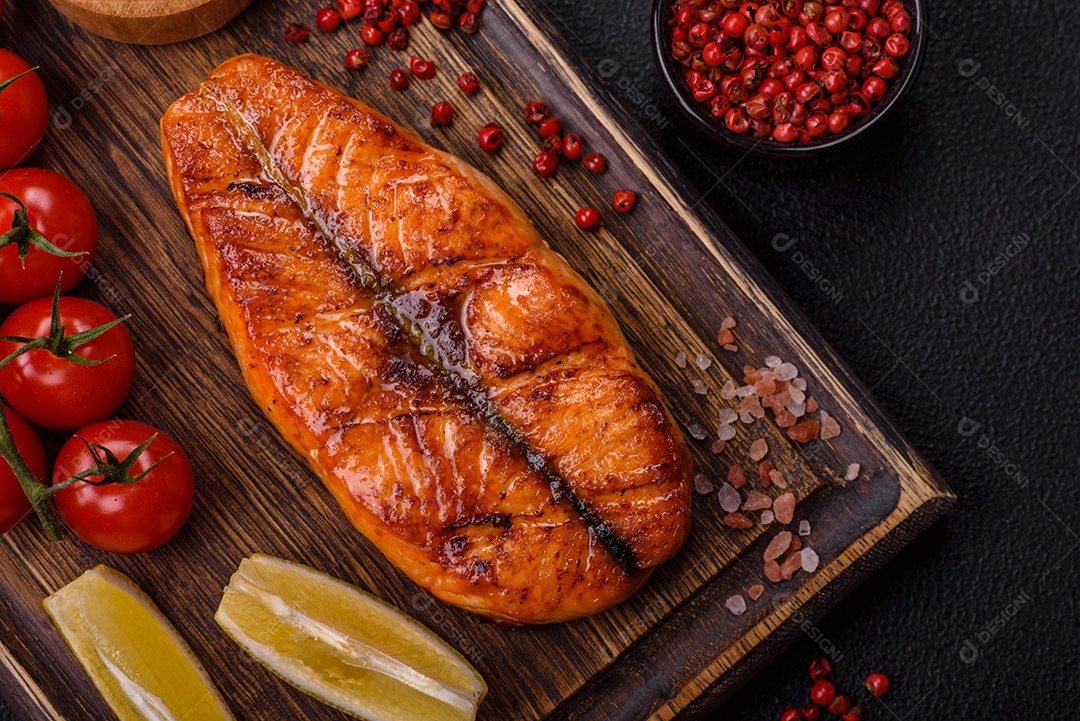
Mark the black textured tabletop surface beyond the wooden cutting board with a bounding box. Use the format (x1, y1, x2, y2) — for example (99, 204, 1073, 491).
(0, 0, 1080, 721)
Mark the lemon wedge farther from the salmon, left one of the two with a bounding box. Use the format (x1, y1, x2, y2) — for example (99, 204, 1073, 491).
(44, 566, 232, 721)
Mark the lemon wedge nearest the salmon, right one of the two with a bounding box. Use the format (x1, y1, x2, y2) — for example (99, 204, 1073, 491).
(215, 554, 487, 721)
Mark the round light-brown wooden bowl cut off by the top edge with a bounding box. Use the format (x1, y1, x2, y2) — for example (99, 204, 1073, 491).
(50, 0, 252, 45)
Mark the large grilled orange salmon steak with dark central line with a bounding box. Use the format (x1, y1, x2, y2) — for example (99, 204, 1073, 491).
(162, 55, 690, 624)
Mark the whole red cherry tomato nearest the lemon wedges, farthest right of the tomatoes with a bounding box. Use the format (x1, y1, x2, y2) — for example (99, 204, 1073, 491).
(53, 420, 195, 554)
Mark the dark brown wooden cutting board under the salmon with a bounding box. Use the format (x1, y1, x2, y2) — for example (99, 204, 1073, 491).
(0, 0, 954, 721)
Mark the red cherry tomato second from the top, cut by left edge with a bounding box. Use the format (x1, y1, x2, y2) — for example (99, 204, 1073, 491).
(0, 168, 97, 305)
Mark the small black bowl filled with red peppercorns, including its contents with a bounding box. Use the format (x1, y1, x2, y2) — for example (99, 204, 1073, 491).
(652, 0, 926, 158)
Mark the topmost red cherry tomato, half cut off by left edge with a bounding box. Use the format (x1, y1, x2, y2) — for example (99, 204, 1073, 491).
(0, 49, 49, 171)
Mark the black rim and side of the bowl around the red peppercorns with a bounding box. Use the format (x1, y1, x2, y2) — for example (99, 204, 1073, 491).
(652, 0, 927, 159)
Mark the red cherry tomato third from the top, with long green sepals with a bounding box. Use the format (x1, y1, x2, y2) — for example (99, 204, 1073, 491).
(0, 296, 135, 431)
